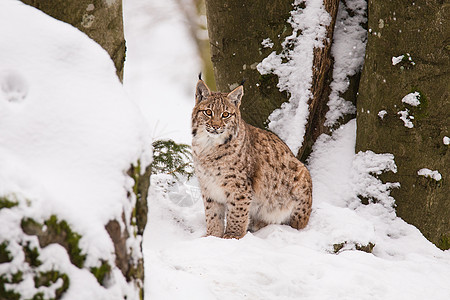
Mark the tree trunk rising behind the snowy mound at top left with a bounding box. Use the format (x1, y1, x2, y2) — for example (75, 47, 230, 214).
(22, 0, 126, 81)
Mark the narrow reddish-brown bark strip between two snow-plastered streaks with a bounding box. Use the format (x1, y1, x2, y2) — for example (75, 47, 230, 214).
(297, 0, 339, 161)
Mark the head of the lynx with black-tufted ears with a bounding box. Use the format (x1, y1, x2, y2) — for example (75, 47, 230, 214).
(192, 79, 244, 143)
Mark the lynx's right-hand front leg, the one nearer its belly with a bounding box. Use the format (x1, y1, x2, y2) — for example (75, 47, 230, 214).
(223, 196, 250, 239)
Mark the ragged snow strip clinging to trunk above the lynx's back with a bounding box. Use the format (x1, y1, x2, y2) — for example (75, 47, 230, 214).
(257, 0, 330, 153)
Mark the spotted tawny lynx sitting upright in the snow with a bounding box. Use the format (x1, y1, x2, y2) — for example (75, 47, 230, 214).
(192, 78, 312, 239)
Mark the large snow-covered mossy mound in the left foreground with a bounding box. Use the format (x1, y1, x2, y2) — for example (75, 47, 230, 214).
(0, 0, 151, 299)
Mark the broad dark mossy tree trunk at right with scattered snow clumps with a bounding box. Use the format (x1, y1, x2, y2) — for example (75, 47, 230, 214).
(356, 0, 450, 249)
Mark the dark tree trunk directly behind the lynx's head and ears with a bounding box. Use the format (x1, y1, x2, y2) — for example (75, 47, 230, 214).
(206, 0, 292, 128)
